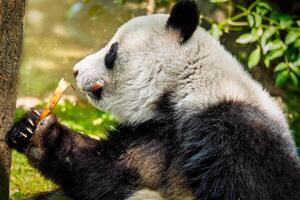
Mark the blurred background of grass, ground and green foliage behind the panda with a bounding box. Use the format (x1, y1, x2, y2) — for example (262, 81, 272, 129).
(10, 0, 300, 200)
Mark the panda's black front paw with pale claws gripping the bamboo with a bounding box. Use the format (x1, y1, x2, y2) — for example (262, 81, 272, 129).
(6, 110, 40, 152)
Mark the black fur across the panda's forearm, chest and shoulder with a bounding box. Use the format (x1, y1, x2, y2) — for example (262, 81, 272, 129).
(6, 101, 300, 200)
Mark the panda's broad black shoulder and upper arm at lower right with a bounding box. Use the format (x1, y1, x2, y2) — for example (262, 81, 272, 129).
(180, 104, 300, 200)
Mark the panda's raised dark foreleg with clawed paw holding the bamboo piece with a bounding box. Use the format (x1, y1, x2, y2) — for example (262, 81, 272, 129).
(7, 113, 138, 200)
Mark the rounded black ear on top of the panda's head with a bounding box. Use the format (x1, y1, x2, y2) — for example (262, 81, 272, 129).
(167, 0, 199, 43)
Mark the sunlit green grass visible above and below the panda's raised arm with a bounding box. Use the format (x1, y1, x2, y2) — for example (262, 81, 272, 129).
(10, 102, 116, 200)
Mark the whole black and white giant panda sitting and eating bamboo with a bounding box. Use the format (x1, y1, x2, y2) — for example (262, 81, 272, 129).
(7, 0, 300, 200)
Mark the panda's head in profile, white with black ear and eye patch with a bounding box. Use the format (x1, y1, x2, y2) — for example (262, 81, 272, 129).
(74, 1, 203, 123)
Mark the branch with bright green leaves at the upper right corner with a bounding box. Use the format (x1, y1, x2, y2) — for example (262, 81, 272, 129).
(207, 0, 300, 90)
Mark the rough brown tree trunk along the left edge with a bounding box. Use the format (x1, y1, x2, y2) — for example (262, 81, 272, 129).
(0, 0, 25, 200)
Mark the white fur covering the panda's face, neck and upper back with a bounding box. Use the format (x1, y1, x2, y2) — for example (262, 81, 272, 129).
(75, 14, 293, 155)
